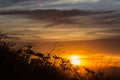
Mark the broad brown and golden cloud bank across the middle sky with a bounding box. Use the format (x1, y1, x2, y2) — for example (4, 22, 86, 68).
(0, 10, 120, 41)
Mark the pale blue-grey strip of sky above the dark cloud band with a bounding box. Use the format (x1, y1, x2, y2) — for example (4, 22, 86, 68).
(0, 0, 120, 10)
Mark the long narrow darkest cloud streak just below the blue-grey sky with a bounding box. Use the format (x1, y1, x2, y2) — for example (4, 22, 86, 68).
(0, 9, 114, 15)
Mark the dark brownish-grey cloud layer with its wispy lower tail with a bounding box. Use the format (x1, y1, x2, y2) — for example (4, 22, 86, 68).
(0, 9, 120, 27)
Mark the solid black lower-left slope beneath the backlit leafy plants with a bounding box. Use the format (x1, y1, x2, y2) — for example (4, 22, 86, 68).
(0, 42, 64, 80)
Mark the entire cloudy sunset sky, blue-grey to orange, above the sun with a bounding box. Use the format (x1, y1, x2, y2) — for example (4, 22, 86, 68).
(0, 0, 120, 64)
